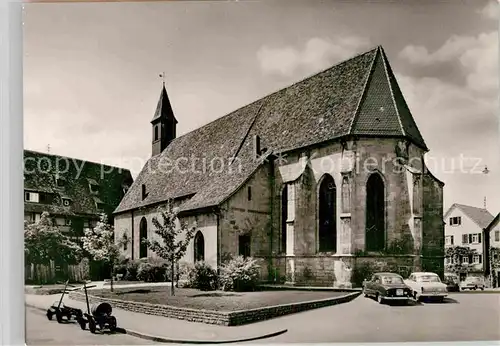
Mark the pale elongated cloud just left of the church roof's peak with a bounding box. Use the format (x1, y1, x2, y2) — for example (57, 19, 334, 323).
(257, 37, 370, 77)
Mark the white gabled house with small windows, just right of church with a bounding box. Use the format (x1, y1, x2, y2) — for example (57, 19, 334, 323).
(444, 203, 494, 280)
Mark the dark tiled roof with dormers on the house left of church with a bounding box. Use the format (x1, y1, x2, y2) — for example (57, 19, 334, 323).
(24, 150, 132, 215)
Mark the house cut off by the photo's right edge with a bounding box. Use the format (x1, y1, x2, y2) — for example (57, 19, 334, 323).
(484, 213, 500, 287)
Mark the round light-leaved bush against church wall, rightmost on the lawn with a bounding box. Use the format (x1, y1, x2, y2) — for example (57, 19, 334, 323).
(220, 256, 260, 292)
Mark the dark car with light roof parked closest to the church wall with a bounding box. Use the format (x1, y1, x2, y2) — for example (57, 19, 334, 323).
(363, 273, 412, 304)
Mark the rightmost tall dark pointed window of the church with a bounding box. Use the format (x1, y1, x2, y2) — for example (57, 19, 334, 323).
(365, 173, 385, 251)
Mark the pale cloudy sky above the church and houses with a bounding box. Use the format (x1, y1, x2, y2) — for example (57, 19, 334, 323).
(24, 0, 500, 214)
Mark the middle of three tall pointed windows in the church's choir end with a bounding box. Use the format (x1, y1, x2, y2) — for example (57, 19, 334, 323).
(318, 174, 337, 252)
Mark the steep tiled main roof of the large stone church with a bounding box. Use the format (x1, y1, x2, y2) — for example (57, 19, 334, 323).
(115, 47, 427, 213)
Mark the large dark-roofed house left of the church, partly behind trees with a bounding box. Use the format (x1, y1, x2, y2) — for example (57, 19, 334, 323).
(24, 150, 133, 281)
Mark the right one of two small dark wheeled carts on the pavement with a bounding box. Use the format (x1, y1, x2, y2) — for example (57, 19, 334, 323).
(79, 284, 116, 333)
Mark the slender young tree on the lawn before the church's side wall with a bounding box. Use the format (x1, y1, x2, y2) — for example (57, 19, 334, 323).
(144, 202, 196, 295)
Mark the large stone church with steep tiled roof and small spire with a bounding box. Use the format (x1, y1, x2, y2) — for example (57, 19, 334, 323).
(115, 46, 444, 287)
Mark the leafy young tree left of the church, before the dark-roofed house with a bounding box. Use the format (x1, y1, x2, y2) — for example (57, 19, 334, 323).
(82, 214, 129, 292)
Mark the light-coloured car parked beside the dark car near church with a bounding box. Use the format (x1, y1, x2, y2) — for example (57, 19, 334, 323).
(405, 272, 448, 302)
